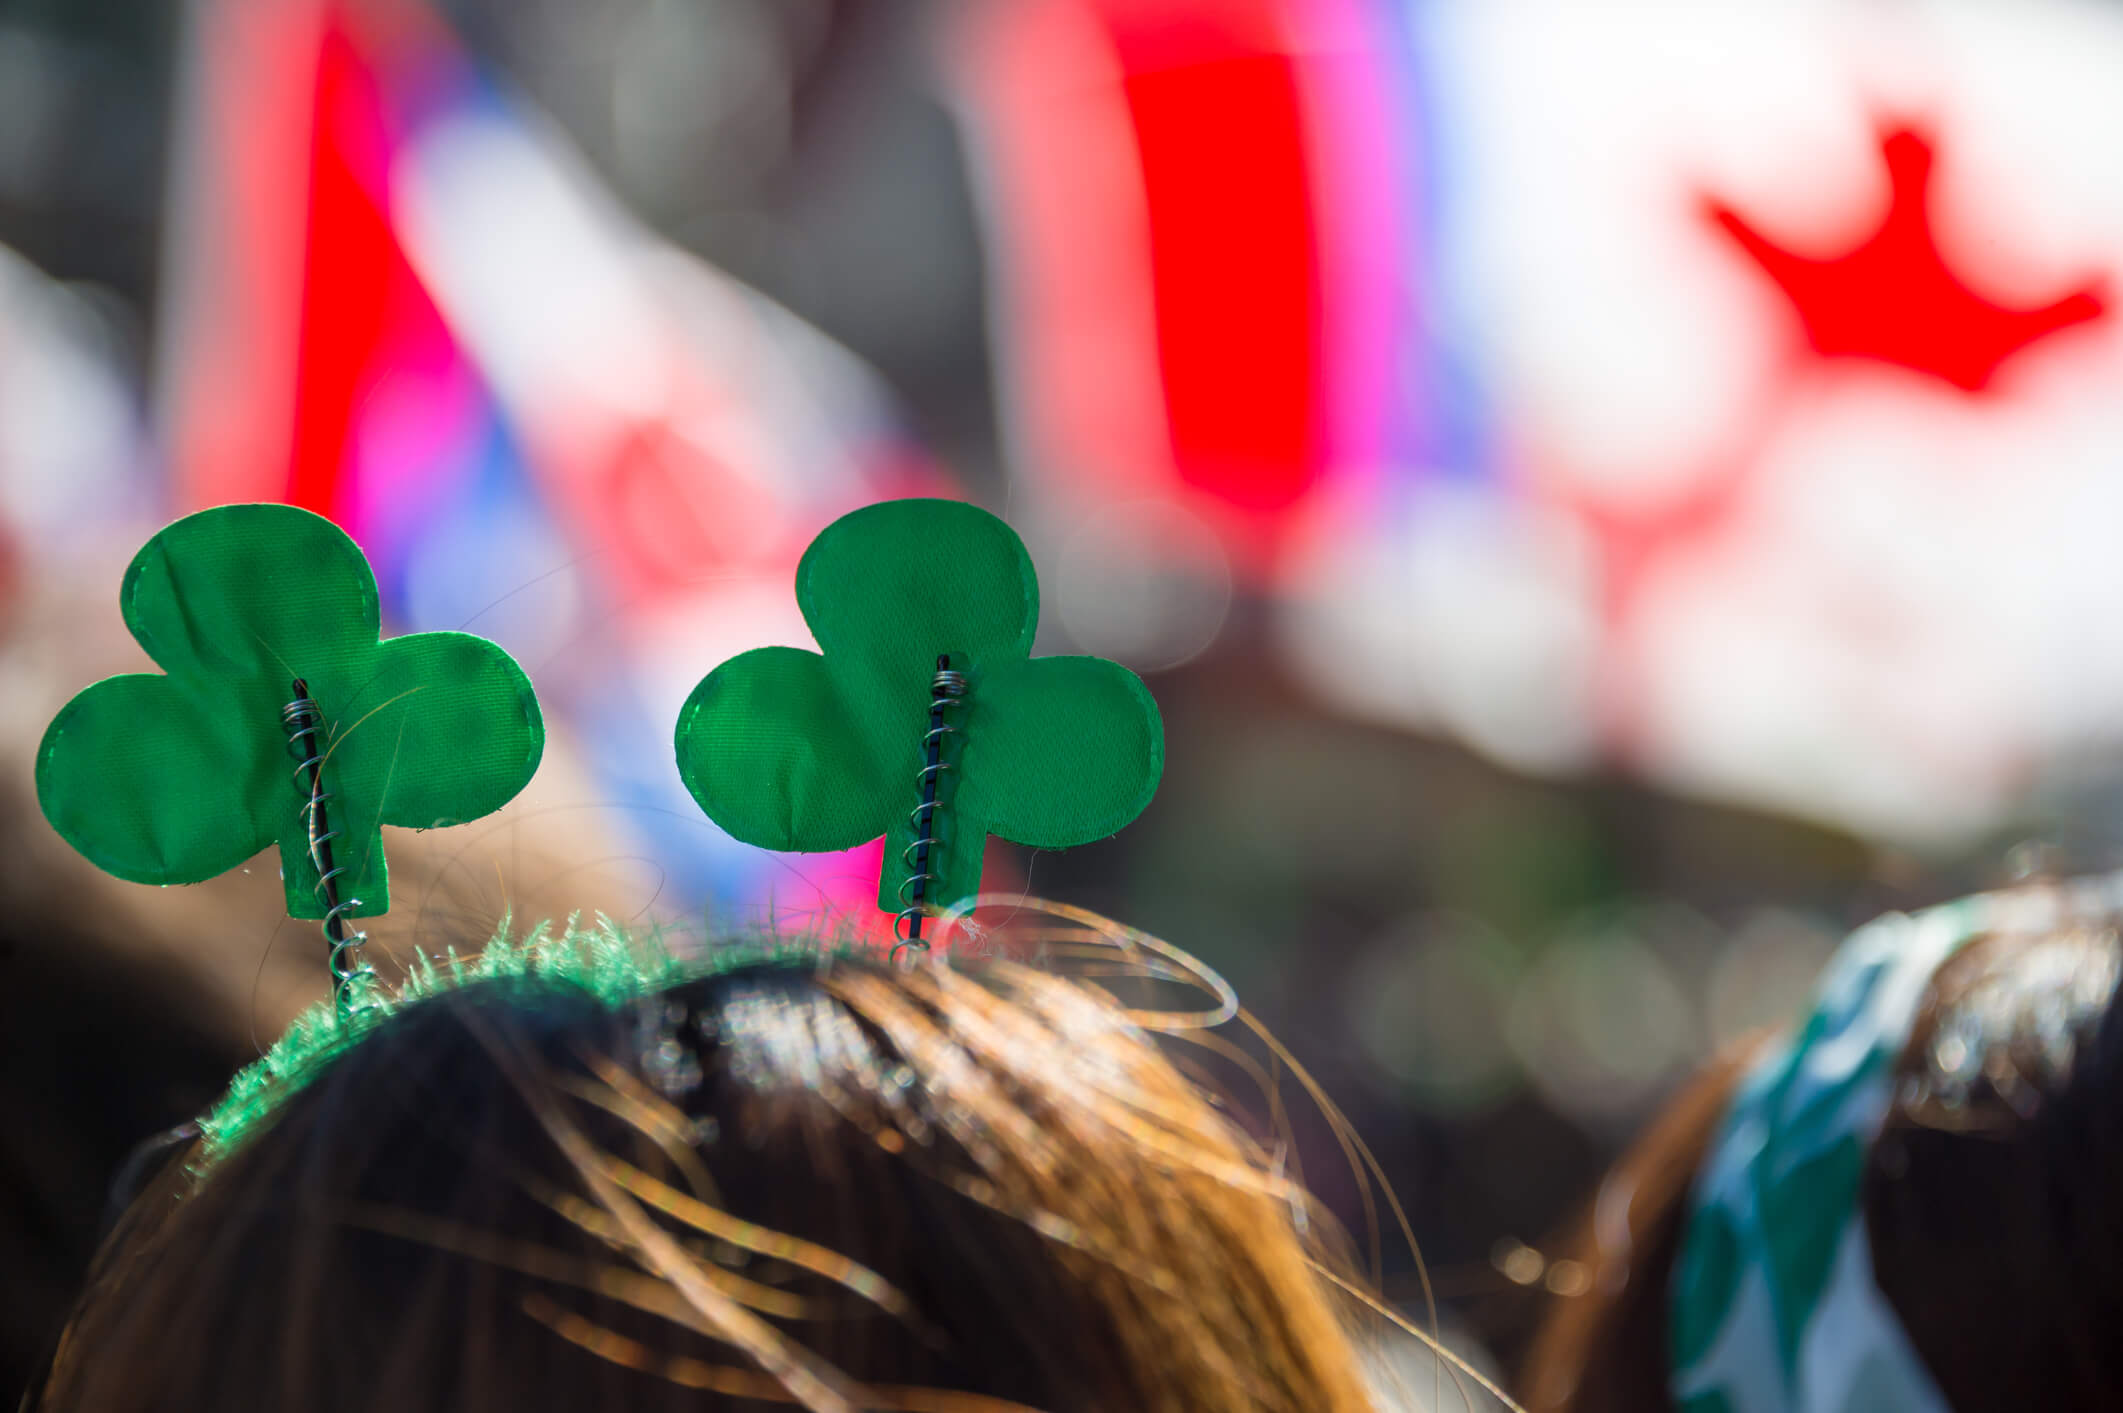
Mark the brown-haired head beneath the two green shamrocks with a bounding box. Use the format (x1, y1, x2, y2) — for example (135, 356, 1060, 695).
(34, 925, 1369, 1413)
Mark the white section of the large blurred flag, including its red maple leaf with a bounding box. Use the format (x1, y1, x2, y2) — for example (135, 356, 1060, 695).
(1284, 0, 2123, 844)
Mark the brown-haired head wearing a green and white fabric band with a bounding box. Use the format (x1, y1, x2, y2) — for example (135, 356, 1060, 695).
(1526, 880, 2123, 1413)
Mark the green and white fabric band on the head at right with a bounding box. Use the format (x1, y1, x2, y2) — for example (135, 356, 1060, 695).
(1669, 897, 2000, 1413)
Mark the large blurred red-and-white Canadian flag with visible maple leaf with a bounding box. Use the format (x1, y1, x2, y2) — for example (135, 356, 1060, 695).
(947, 0, 2123, 842)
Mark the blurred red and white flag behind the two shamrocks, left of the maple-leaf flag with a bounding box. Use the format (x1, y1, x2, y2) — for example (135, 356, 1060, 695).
(161, 0, 938, 908)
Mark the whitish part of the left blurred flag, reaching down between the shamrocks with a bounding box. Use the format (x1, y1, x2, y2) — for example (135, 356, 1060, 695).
(391, 82, 945, 914)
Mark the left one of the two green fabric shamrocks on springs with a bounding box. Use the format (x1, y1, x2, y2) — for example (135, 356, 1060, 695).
(36, 505, 546, 919)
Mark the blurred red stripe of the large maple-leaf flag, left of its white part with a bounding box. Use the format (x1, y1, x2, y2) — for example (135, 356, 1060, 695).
(949, 0, 1422, 611)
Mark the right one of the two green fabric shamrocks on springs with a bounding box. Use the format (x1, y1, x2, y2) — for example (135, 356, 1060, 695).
(677, 501, 1166, 912)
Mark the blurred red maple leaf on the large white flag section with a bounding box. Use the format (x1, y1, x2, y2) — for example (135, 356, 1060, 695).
(1705, 127, 2108, 393)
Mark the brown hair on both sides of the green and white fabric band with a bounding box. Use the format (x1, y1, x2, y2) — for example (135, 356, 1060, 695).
(1524, 903, 2123, 1413)
